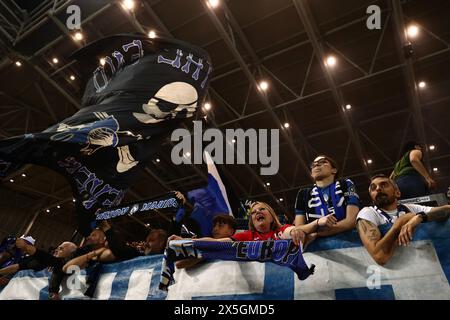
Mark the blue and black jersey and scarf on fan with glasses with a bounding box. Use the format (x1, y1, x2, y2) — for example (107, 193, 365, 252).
(295, 179, 360, 222)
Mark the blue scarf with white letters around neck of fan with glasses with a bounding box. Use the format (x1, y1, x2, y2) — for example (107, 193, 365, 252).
(307, 181, 346, 221)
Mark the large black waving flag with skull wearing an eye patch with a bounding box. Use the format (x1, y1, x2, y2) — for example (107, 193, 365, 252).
(0, 34, 212, 234)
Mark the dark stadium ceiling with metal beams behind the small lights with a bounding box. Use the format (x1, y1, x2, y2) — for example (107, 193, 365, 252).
(0, 0, 450, 250)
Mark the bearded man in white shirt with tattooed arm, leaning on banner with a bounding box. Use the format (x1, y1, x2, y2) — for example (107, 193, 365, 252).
(357, 174, 450, 265)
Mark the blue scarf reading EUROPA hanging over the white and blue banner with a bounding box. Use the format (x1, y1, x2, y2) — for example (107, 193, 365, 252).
(159, 239, 315, 290)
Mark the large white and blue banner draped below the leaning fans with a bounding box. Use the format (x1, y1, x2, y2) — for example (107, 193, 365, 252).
(0, 221, 450, 300)
